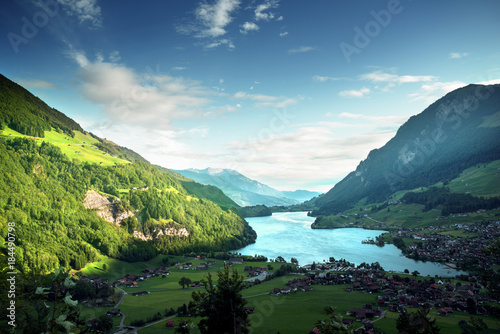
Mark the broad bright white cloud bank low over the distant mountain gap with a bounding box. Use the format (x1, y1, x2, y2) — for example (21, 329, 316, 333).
(228, 124, 395, 190)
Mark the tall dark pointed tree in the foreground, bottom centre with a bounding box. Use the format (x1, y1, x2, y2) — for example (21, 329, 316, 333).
(192, 267, 250, 334)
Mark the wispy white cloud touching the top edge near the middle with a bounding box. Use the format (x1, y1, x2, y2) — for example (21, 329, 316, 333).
(195, 0, 240, 38)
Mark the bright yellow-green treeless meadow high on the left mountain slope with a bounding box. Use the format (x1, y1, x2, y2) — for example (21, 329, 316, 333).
(0, 127, 130, 166)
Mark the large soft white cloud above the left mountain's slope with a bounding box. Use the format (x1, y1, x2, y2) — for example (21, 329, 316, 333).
(67, 50, 212, 129)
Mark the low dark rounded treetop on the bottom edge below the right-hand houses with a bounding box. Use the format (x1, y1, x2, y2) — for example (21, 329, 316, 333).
(396, 309, 441, 334)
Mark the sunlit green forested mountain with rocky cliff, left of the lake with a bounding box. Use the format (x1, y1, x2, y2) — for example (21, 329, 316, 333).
(0, 76, 256, 273)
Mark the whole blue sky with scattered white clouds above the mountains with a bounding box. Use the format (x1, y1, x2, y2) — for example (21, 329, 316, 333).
(0, 0, 500, 191)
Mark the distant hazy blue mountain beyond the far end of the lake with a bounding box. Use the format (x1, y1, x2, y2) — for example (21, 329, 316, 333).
(175, 168, 319, 206)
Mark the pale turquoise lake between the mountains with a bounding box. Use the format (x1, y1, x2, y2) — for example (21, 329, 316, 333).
(236, 212, 459, 277)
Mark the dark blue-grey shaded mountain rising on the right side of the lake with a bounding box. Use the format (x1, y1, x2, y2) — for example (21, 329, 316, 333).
(309, 85, 500, 216)
